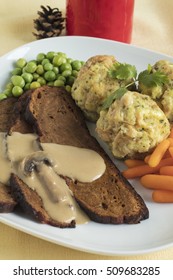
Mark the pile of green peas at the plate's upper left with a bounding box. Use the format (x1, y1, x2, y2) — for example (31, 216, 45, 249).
(0, 51, 84, 100)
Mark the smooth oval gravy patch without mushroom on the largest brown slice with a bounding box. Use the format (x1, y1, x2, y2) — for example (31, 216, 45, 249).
(41, 143, 105, 183)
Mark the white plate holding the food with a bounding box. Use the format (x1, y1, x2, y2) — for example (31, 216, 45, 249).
(0, 37, 173, 255)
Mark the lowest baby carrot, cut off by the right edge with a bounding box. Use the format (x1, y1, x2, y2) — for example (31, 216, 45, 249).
(152, 190, 173, 203)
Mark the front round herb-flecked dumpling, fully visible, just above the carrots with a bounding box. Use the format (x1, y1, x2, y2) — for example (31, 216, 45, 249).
(96, 91, 170, 159)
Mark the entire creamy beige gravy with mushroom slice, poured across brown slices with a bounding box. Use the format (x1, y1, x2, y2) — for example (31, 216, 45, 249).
(0, 132, 106, 224)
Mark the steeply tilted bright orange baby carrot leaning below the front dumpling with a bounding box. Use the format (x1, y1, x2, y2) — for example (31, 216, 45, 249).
(148, 139, 170, 167)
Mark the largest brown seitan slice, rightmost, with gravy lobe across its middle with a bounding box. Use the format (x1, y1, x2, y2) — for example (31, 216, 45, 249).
(21, 86, 149, 224)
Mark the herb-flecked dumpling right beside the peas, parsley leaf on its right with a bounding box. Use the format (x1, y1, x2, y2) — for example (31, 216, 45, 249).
(71, 55, 133, 122)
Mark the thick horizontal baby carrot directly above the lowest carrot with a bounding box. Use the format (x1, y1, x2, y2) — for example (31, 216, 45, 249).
(140, 174, 173, 191)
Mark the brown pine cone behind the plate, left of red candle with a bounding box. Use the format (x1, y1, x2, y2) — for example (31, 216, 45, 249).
(33, 6, 65, 39)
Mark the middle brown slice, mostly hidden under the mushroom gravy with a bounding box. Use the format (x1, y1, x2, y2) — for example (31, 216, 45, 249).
(8, 90, 75, 228)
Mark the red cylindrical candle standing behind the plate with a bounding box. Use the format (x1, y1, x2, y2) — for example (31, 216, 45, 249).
(66, 0, 134, 43)
